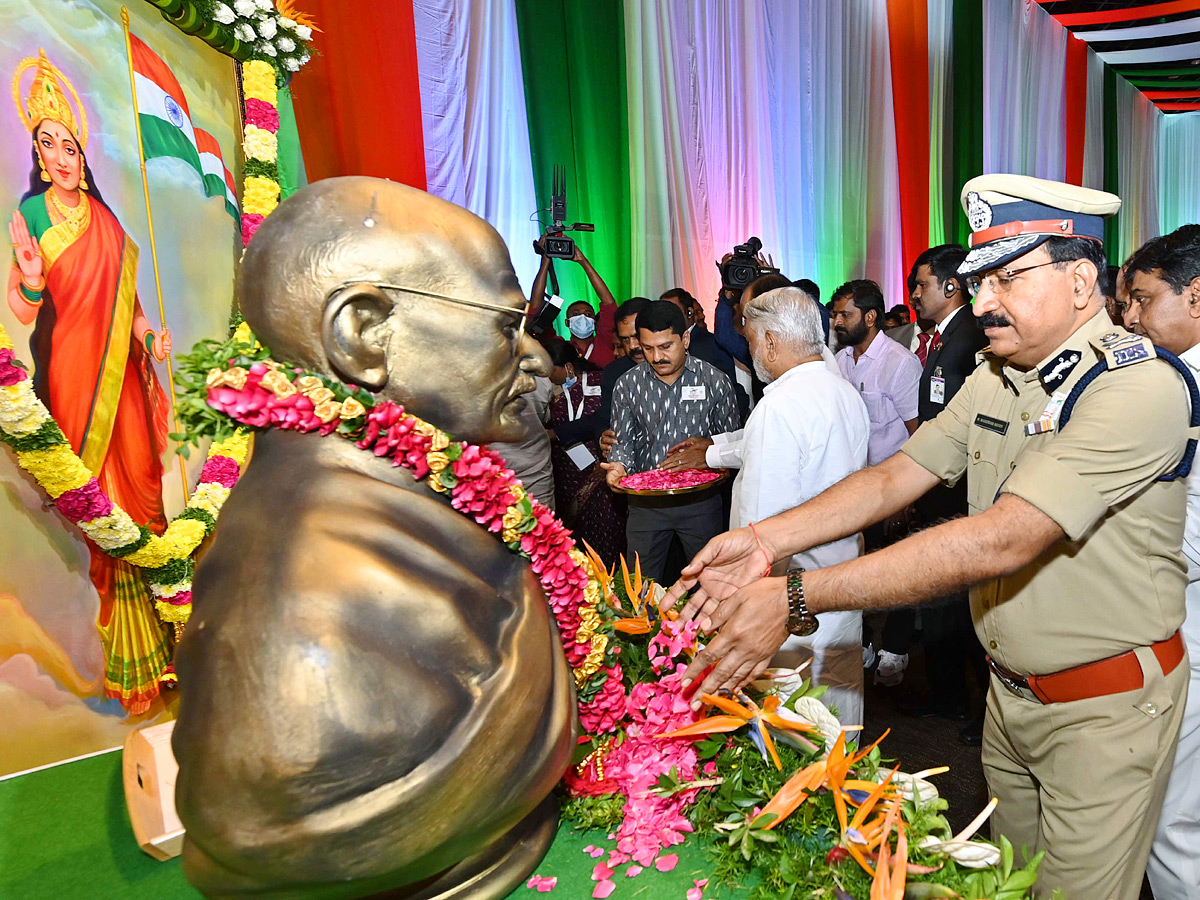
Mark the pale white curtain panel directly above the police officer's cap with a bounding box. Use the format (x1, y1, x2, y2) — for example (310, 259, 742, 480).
(983, 0, 1067, 181)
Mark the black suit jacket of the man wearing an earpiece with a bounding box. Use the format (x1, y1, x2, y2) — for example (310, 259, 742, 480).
(917, 306, 988, 526)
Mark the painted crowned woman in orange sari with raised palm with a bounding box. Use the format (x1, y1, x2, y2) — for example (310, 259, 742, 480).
(8, 50, 170, 714)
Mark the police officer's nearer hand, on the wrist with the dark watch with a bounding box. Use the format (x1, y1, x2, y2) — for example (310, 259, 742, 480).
(683, 572, 787, 709)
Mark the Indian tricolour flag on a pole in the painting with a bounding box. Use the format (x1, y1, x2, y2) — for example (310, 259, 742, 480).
(130, 34, 238, 218)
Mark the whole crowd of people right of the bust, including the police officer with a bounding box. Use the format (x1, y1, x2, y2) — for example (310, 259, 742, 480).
(487, 175, 1200, 900)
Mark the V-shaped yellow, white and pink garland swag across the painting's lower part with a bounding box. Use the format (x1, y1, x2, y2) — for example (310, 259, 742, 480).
(0, 325, 250, 623)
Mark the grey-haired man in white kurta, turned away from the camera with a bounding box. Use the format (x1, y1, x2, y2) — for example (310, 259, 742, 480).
(730, 288, 871, 725)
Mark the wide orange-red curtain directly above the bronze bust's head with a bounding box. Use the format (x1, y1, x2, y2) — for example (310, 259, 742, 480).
(292, 0, 425, 191)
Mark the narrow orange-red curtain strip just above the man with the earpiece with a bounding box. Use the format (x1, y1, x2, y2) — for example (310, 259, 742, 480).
(888, 0, 929, 278)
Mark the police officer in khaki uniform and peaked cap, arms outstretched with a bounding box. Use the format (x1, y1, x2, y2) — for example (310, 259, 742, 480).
(671, 175, 1198, 900)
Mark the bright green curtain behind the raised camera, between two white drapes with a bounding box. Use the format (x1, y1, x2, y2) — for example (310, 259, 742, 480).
(516, 0, 631, 308)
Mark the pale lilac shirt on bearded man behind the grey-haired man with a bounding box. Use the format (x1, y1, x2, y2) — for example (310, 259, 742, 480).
(838, 331, 920, 466)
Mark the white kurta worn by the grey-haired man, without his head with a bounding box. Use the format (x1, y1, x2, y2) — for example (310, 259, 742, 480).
(730, 360, 871, 725)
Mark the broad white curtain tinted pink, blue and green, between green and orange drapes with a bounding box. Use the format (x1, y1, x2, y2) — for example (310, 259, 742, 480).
(625, 0, 904, 305)
